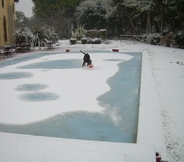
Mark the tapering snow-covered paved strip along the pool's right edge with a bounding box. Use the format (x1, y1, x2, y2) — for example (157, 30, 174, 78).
(137, 51, 168, 160)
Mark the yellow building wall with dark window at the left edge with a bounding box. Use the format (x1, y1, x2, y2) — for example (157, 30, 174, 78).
(0, 0, 19, 46)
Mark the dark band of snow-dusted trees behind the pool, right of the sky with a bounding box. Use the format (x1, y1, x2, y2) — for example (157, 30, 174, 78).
(29, 0, 184, 39)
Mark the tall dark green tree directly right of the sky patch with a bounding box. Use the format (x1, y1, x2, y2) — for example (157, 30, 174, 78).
(33, 0, 81, 38)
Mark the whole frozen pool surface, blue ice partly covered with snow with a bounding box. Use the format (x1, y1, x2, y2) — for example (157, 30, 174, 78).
(0, 51, 142, 143)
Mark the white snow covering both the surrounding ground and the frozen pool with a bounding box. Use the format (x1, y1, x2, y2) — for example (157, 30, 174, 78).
(0, 40, 184, 162)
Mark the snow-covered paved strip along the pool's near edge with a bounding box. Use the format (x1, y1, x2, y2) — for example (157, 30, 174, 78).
(0, 133, 155, 162)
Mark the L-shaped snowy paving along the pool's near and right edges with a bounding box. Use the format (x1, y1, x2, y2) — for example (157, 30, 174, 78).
(0, 48, 166, 162)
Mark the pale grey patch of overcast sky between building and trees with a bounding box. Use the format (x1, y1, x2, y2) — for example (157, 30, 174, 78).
(15, 0, 33, 17)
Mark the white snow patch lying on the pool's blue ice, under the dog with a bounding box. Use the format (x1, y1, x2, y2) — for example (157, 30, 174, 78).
(0, 53, 132, 124)
